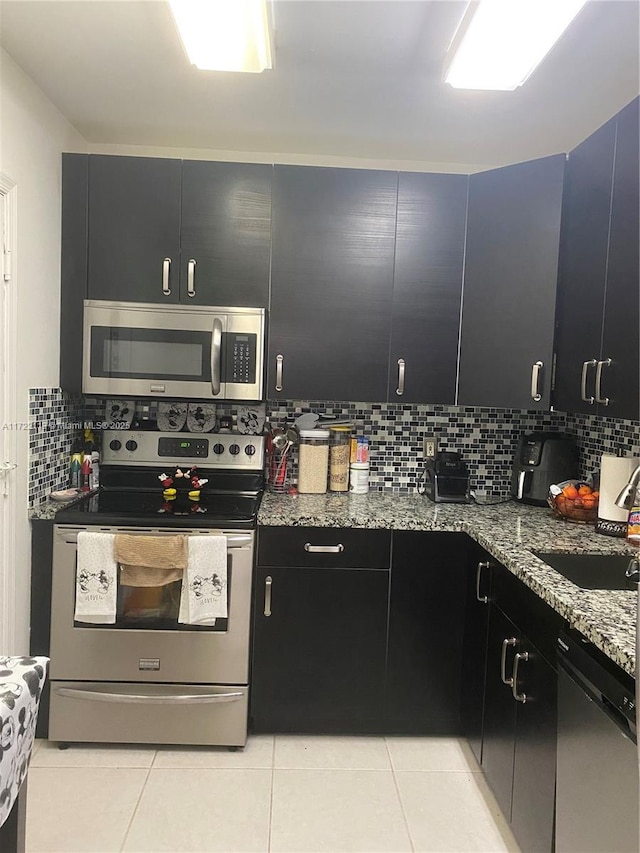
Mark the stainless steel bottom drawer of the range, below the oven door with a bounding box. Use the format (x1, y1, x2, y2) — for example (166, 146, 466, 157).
(49, 681, 249, 746)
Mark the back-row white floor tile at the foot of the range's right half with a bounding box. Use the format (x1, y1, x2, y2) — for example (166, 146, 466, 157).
(153, 735, 274, 770)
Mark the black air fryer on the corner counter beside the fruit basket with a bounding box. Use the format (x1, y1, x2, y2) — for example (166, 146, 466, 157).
(511, 432, 578, 506)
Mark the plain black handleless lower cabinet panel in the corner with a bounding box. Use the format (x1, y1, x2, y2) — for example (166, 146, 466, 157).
(385, 532, 467, 735)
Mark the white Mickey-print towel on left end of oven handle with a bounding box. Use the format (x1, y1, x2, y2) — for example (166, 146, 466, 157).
(74, 531, 118, 625)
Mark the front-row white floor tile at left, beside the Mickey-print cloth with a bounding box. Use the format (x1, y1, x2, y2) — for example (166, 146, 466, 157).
(26, 767, 148, 853)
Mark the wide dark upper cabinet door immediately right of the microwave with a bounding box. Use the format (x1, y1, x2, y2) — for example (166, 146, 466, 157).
(268, 166, 398, 401)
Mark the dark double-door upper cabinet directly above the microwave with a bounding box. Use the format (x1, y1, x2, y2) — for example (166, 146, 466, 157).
(87, 155, 272, 308)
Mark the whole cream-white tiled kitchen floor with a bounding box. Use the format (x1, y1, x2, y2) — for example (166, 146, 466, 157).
(27, 735, 518, 853)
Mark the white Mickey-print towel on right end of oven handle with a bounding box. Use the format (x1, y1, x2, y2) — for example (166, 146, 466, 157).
(178, 535, 227, 625)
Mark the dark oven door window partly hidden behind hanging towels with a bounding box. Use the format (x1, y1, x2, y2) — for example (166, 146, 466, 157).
(73, 559, 232, 633)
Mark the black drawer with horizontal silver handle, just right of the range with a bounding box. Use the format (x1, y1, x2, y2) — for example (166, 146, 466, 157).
(258, 527, 391, 569)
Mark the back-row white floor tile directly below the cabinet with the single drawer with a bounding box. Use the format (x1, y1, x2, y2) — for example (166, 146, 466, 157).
(274, 735, 391, 770)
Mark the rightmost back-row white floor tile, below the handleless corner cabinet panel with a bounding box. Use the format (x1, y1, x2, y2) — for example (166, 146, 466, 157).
(386, 737, 481, 773)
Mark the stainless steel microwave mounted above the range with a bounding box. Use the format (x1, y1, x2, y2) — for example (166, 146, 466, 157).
(82, 299, 265, 401)
